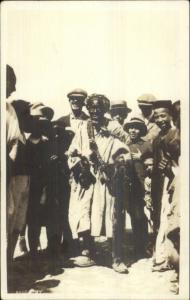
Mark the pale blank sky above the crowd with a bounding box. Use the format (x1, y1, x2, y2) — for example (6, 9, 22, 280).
(2, 1, 189, 118)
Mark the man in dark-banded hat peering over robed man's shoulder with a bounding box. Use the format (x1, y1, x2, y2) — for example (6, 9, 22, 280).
(108, 100, 131, 144)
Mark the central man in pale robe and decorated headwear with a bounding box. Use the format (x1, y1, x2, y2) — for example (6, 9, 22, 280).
(69, 94, 131, 273)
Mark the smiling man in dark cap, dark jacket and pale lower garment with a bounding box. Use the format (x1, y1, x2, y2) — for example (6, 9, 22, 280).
(152, 100, 180, 271)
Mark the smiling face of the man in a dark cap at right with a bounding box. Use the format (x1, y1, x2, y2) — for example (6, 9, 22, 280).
(154, 108, 171, 131)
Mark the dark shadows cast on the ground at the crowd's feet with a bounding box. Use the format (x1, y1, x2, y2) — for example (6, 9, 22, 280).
(7, 230, 150, 293)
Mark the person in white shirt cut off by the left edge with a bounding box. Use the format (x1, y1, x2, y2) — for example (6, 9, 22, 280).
(6, 65, 29, 267)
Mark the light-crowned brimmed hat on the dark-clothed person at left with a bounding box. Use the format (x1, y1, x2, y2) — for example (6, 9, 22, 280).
(30, 102, 54, 120)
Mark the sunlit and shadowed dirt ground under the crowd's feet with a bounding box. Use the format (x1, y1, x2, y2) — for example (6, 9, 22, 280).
(8, 229, 179, 300)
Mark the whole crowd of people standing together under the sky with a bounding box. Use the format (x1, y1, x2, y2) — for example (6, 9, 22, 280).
(7, 66, 180, 284)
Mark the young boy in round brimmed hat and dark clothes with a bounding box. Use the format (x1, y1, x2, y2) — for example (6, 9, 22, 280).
(124, 118, 152, 259)
